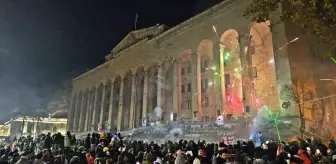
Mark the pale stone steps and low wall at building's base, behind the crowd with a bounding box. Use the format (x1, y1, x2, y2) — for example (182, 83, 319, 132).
(80, 114, 317, 143)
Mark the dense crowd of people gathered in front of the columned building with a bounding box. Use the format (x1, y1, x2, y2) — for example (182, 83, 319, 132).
(0, 132, 336, 164)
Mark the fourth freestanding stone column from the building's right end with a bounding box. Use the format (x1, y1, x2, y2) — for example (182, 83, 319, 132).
(173, 59, 181, 118)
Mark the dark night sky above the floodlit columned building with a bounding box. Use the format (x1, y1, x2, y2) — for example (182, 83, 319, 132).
(0, 0, 220, 119)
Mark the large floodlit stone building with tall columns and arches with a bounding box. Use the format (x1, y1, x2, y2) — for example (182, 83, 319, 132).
(68, 0, 336, 132)
